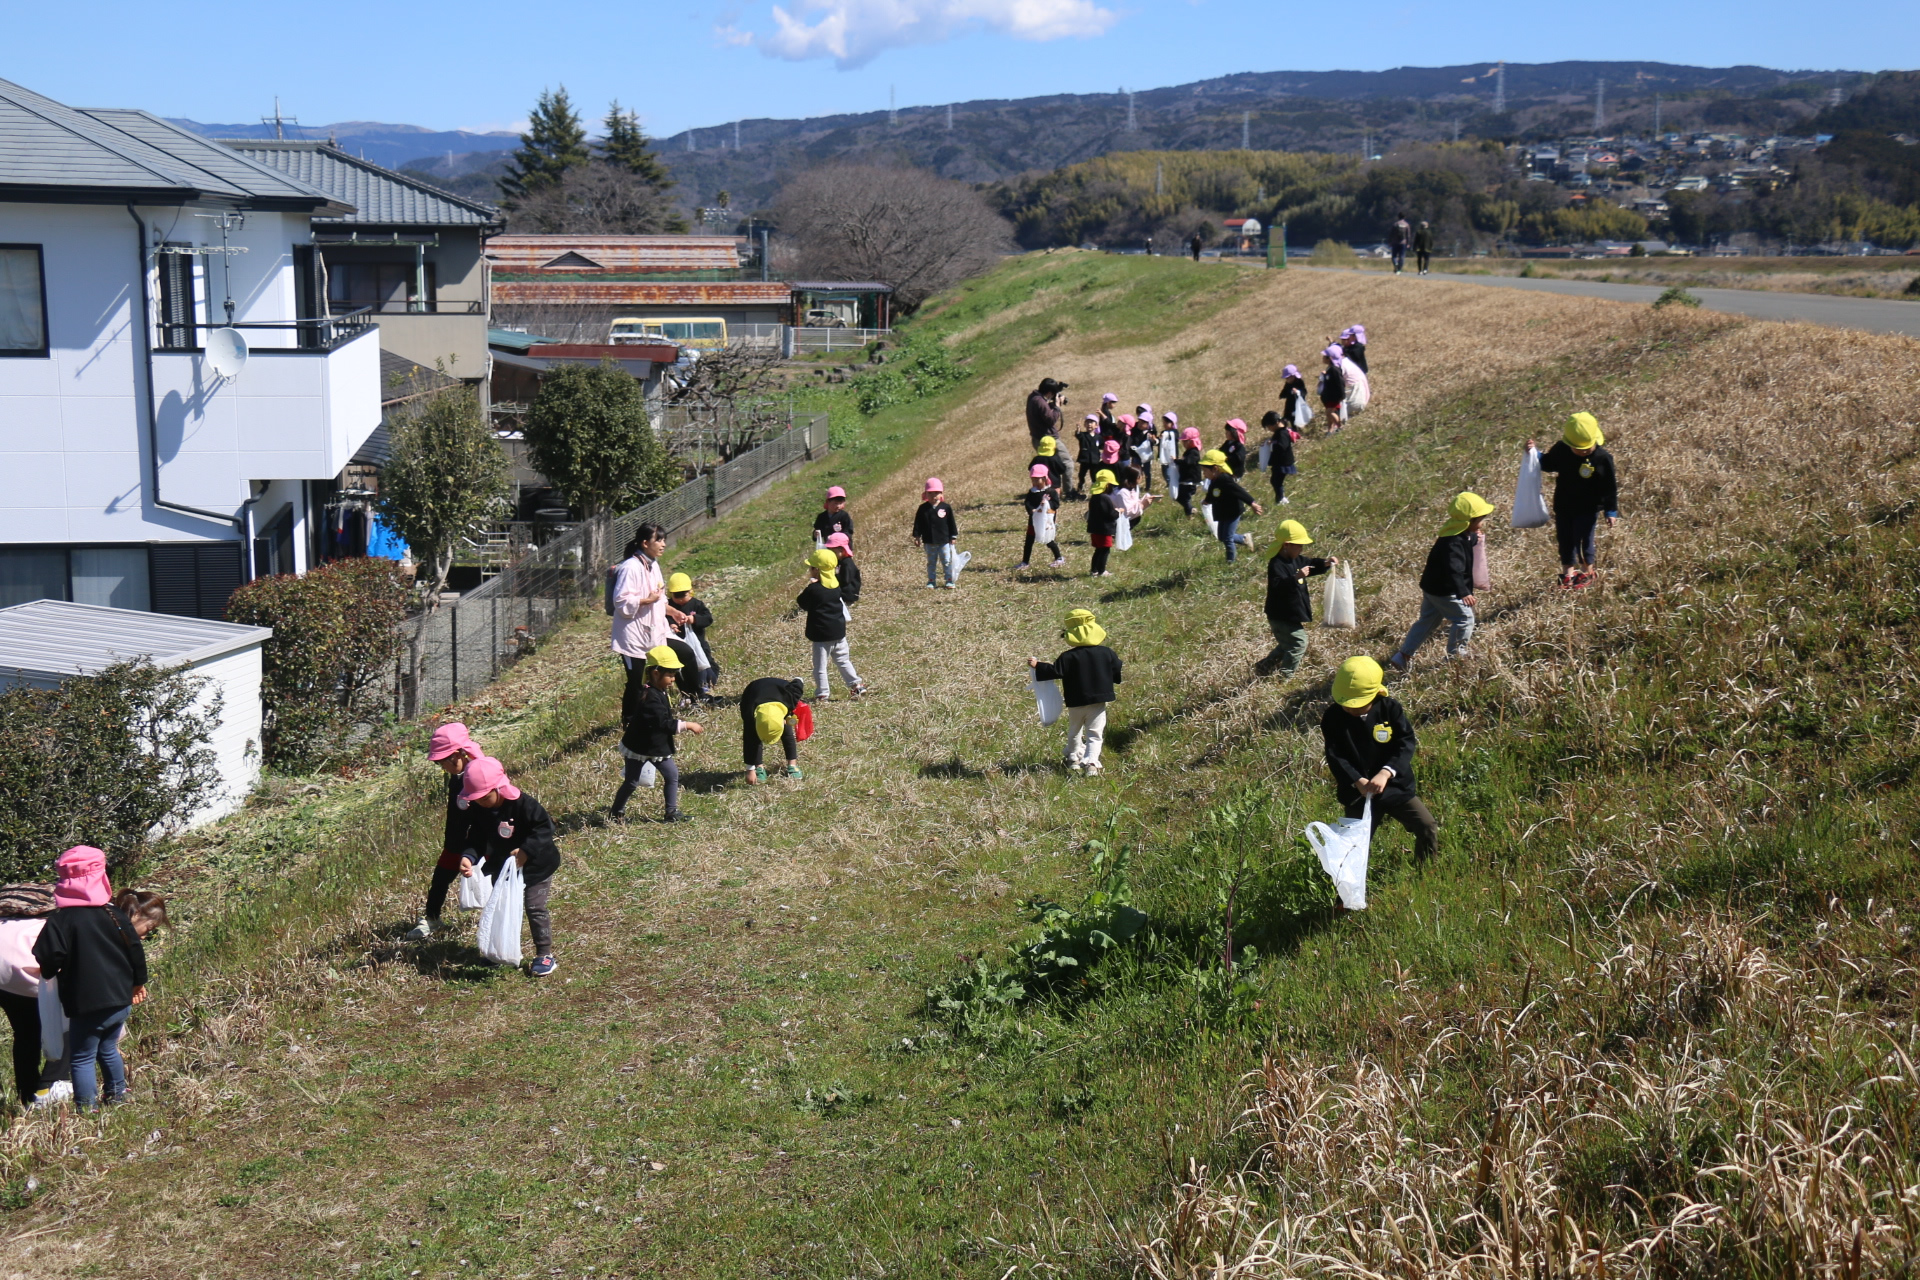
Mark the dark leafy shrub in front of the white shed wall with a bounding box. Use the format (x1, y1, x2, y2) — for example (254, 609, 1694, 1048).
(0, 658, 221, 881)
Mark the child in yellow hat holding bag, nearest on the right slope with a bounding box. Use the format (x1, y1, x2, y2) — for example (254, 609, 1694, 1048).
(1321, 658, 1440, 862)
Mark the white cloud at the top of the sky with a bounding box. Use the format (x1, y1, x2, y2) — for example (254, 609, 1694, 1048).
(741, 0, 1119, 71)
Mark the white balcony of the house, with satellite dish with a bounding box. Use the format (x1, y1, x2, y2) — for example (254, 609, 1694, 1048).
(154, 317, 380, 510)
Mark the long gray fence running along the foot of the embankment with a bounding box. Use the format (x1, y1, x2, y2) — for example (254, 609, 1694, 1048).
(396, 413, 828, 710)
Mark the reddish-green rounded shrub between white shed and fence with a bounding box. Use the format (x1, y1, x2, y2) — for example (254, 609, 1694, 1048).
(227, 558, 411, 770)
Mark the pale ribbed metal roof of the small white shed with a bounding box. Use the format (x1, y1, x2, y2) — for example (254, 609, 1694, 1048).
(0, 601, 273, 681)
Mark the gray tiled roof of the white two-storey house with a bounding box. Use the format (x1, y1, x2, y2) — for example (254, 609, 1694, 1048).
(0, 81, 349, 215)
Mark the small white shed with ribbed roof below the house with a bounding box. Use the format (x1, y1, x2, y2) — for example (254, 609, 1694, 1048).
(0, 601, 273, 827)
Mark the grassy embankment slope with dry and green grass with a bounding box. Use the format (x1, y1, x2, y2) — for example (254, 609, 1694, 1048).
(10, 253, 1920, 1276)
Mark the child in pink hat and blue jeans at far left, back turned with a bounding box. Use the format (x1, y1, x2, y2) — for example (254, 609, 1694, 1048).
(33, 844, 146, 1109)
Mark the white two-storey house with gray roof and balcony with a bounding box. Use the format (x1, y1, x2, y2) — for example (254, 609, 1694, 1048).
(0, 81, 380, 618)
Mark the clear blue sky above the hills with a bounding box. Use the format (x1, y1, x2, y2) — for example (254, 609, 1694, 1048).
(0, 0, 1920, 136)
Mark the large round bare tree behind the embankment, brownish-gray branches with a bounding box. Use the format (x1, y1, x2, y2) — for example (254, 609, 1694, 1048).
(774, 165, 1014, 313)
